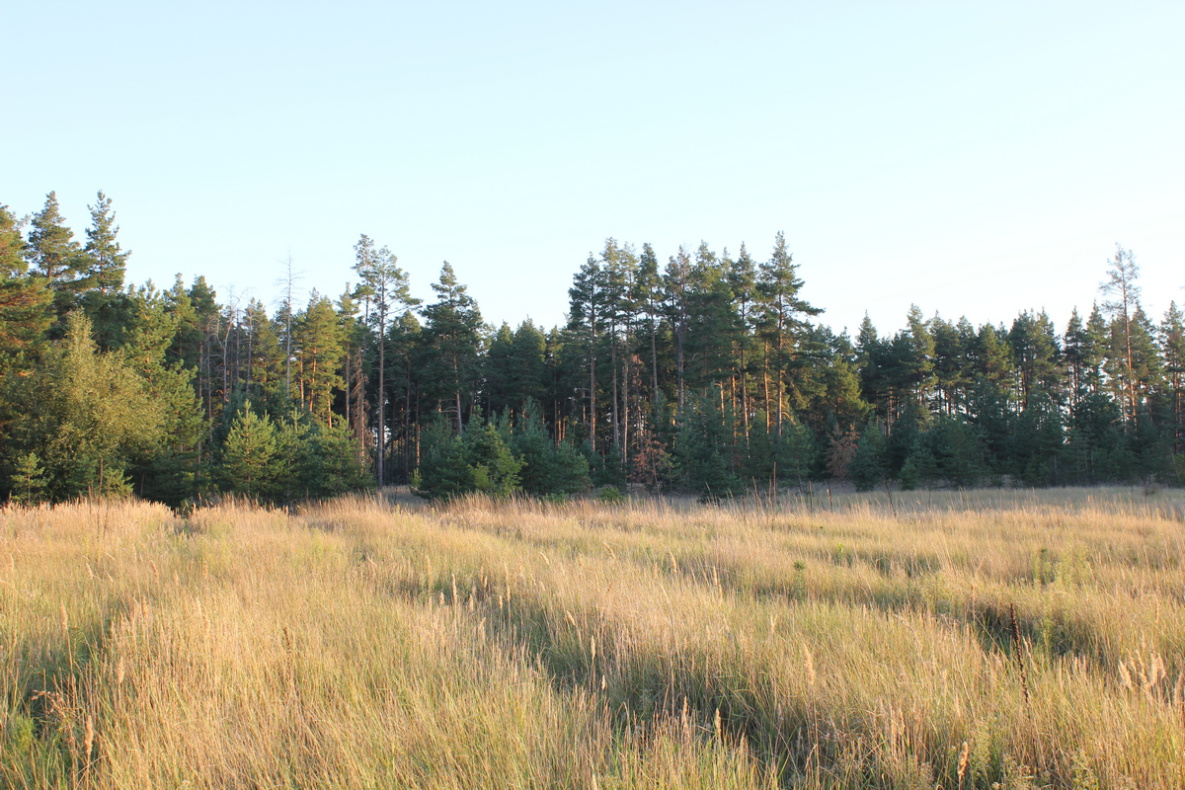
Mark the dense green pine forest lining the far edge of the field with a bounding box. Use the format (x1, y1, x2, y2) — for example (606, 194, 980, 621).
(0, 192, 1185, 506)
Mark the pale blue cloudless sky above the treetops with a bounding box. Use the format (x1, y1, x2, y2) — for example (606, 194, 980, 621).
(0, 0, 1185, 332)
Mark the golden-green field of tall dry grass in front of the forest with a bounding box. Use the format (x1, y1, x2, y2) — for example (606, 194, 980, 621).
(0, 489, 1185, 790)
